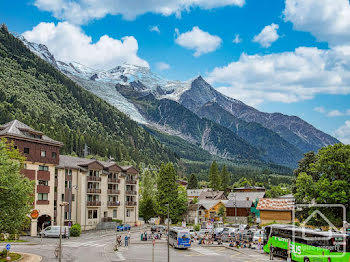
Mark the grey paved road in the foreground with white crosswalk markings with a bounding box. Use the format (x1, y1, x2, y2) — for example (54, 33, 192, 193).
(0, 231, 279, 262)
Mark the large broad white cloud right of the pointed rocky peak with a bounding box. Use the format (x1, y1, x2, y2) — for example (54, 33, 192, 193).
(206, 47, 350, 106)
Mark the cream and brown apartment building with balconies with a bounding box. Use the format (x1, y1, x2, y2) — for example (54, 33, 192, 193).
(0, 120, 139, 236)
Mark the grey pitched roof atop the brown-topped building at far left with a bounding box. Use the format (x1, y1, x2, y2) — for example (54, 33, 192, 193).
(0, 120, 63, 146)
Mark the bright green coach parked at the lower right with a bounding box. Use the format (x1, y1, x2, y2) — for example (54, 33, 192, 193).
(264, 225, 350, 262)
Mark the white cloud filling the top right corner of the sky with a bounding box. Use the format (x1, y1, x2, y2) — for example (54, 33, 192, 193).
(283, 0, 350, 46)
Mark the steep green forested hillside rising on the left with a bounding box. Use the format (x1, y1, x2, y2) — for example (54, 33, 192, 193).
(0, 26, 178, 164)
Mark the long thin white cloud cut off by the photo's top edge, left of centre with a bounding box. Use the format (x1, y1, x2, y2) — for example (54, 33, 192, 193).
(34, 0, 245, 24)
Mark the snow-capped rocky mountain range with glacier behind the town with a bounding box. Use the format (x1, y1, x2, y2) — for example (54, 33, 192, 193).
(21, 37, 339, 167)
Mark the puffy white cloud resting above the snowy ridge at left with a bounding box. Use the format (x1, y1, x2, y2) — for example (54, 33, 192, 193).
(23, 22, 149, 69)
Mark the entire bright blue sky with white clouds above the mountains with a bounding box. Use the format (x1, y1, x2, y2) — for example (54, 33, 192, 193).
(0, 0, 350, 143)
